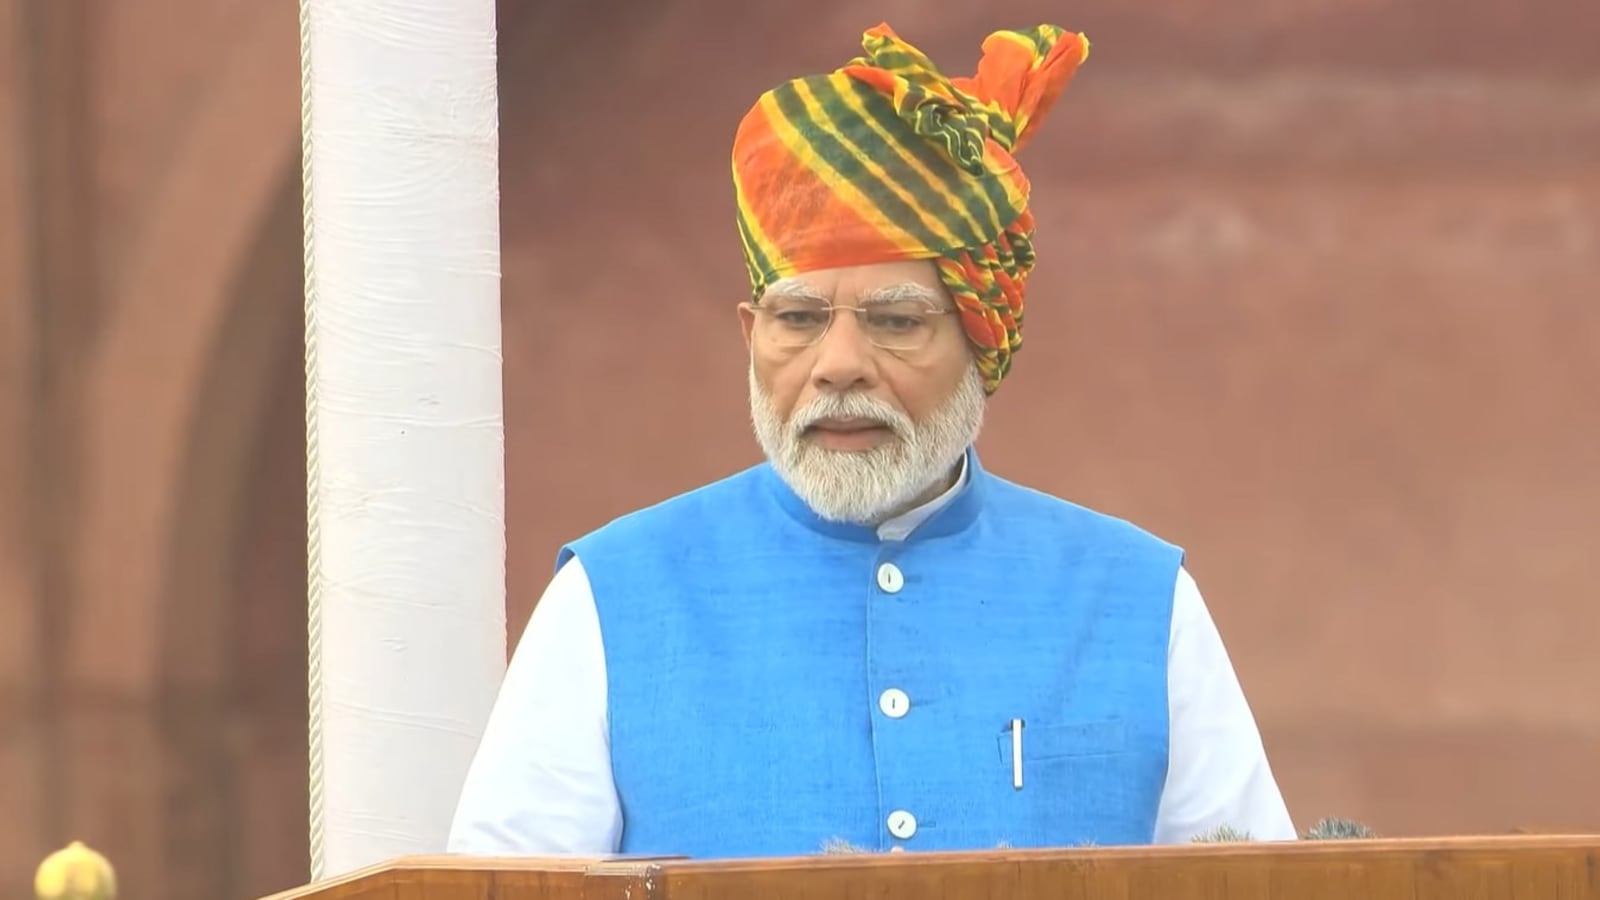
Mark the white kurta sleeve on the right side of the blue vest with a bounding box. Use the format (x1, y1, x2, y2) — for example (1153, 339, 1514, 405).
(1155, 569, 1296, 844)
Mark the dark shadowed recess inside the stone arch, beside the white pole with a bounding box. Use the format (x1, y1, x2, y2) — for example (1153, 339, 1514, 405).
(157, 173, 307, 897)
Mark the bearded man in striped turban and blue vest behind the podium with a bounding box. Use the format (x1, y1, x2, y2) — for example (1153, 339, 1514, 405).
(450, 19, 1294, 858)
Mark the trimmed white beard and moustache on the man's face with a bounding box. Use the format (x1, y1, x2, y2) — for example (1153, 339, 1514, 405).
(750, 358, 986, 525)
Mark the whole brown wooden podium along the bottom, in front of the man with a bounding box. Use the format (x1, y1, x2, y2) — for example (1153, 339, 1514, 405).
(266, 834, 1600, 900)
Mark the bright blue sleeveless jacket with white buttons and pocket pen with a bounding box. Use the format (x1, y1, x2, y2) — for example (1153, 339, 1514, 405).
(558, 453, 1182, 858)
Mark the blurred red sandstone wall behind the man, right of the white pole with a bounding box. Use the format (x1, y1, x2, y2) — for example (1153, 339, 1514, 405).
(492, 0, 1600, 833)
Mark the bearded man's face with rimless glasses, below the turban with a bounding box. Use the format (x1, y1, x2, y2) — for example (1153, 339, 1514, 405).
(739, 261, 984, 525)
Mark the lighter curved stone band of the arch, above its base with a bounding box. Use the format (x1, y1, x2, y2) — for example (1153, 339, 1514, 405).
(67, 3, 299, 700)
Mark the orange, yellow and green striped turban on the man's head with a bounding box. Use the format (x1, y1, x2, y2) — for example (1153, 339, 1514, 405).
(733, 24, 1090, 394)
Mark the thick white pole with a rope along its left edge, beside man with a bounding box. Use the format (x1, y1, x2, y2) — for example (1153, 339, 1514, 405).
(301, 0, 506, 881)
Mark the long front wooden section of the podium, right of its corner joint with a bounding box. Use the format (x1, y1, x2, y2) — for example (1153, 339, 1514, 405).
(649, 836, 1600, 900)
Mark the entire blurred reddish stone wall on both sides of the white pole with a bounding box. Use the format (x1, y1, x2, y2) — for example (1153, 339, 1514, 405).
(0, 0, 1600, 900)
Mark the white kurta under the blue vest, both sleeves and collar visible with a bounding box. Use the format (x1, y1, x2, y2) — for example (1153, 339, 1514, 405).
(450, 463, 1296, 855)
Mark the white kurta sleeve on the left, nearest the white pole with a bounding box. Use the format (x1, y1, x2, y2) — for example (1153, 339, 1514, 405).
(448, 557, 622, 857)
